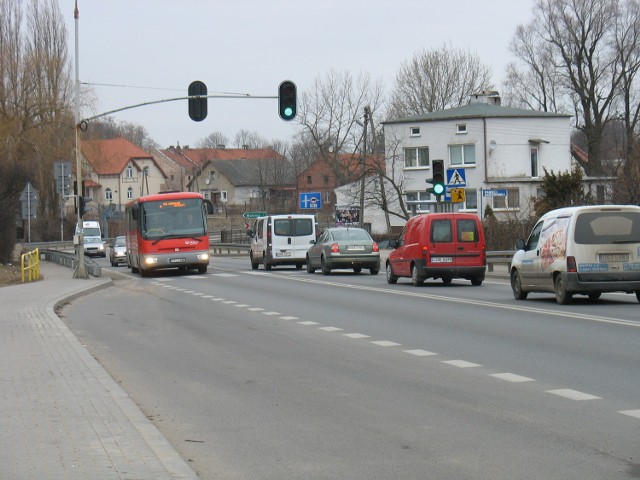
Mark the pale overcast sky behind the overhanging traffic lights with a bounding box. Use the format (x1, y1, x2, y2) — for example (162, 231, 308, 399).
(63, 0, 534, 148)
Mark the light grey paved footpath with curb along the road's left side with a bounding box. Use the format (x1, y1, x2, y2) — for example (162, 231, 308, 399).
(0, 261, 197, 480)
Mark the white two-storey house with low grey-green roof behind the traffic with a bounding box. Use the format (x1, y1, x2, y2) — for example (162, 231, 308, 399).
(380, 92, 572, 227)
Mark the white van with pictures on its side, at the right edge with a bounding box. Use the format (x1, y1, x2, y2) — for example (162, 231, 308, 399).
(510, 205, 640, 304)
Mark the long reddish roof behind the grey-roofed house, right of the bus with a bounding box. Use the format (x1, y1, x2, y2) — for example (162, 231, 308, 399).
(159, 147, 284, 172)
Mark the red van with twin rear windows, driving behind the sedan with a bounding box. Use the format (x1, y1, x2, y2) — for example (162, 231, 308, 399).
(386, 213, 487, 285)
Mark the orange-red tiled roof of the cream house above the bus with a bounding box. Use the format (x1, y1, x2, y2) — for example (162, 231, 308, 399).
(81, 138, 164, 175)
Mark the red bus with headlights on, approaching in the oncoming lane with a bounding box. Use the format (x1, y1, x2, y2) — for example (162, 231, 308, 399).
(125, 192, 213, 277)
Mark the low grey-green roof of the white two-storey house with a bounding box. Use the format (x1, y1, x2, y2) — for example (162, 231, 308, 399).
(382, 103, 571, 124)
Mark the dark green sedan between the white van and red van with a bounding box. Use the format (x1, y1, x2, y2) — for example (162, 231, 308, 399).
(306, 227, 380, 275)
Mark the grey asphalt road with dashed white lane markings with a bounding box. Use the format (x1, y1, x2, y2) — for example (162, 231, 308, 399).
(63, 258, 640, 480)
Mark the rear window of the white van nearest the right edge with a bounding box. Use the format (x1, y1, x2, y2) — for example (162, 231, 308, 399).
(574, 212, 640, 245)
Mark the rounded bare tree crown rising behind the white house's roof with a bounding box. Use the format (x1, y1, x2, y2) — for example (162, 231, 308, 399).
(387, 45, 492, 118)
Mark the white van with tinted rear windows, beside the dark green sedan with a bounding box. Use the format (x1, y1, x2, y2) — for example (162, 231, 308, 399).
(249, 214, 316, 270)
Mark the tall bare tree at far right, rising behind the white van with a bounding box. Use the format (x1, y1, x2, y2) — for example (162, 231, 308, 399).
(513, 0, 640, 175)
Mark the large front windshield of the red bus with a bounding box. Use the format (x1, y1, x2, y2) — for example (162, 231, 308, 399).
(140, 198, 206, 240)
